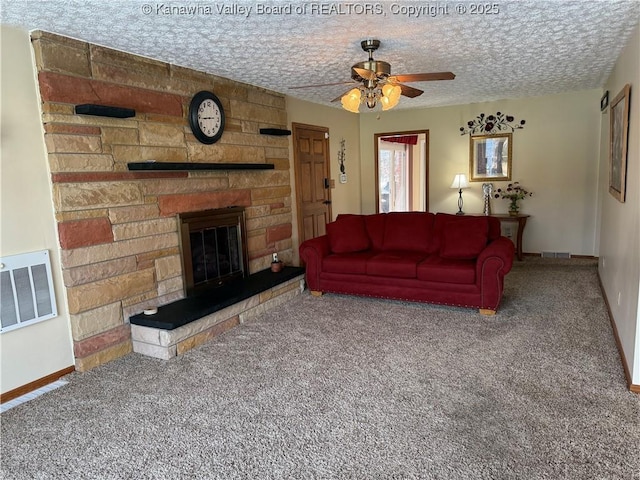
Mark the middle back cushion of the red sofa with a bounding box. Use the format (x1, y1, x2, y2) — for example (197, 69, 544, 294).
(384, 212, 434, 253)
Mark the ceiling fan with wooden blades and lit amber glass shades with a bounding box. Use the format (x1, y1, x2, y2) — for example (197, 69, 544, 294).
(291, 39, 456, 113)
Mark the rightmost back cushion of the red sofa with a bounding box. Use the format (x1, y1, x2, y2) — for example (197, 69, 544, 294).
(440, 217, 489, 260)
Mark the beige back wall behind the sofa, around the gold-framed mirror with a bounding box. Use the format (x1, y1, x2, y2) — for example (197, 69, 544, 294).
(360, 90, 601, 255)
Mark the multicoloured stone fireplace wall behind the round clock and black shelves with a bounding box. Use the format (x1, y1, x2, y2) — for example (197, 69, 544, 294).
(32, 32, 295, 371)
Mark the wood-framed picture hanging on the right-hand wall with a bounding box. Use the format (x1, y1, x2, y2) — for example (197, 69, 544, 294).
(609, 84, 631, 203)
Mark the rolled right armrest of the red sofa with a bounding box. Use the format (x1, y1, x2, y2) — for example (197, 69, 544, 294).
(476, 237, 515, 310)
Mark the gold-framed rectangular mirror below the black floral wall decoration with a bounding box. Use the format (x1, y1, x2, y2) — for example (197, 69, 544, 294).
(469, 133, 513, 182)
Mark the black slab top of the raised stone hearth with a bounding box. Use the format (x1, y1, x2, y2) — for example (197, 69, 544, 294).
(129, 267, 304, 330)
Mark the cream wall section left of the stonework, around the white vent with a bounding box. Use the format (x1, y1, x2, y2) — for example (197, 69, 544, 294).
(0, 26, 73, 393)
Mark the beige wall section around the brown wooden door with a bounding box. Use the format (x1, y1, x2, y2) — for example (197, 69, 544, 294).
(287, 97, 361, 260)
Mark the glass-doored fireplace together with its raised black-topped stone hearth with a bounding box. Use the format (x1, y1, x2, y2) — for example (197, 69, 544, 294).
(129, 207, 304, 359)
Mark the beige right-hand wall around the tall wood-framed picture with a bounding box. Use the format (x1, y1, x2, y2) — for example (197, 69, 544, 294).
(598, 22, 640, 391)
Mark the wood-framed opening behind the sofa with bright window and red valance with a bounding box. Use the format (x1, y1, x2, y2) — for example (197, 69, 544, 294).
(374, 130, 429, 213)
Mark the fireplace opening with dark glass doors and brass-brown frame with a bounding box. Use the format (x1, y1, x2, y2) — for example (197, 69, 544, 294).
(178, 207, 249, 296)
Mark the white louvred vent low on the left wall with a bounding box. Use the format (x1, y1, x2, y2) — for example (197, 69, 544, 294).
(0, 250, 58, 333)
